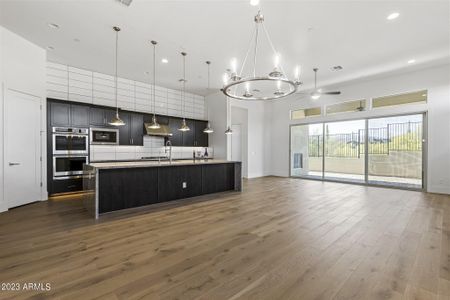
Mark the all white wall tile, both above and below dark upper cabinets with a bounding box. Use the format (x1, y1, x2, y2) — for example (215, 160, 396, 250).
(46, 62, 214, 161)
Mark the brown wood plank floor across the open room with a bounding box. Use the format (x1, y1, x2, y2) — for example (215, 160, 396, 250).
(0, 177, 450, 300)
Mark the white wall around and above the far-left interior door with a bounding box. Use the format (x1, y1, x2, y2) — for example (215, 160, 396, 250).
(0, 27, 47, 211)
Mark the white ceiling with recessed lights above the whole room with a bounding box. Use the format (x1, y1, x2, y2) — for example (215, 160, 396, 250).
(0, 0, 450, 94)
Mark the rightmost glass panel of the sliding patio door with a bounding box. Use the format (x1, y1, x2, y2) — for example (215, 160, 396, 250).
(368, 114, 423, 188)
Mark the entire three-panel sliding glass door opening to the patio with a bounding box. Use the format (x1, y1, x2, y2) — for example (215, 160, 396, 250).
(290, 114, 424, 189)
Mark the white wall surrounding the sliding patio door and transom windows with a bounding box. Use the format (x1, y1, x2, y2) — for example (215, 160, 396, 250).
(271, 65, 450, 193)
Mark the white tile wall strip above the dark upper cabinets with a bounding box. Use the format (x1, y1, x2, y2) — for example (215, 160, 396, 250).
(46, 62, 206, 120)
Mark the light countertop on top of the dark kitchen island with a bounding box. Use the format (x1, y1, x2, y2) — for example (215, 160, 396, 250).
(88, 159, 237, 169)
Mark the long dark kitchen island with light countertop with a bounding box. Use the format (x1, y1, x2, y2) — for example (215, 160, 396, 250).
(83, 159, 242, 218)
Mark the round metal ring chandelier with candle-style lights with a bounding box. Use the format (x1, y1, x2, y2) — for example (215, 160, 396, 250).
(222, 11, 301, 100)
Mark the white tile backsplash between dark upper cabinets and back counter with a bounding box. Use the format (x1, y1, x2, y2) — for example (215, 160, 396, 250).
(90, 136, 214, 162)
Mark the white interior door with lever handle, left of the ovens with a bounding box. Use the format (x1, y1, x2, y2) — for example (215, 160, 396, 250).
(4, 90, 41, 208)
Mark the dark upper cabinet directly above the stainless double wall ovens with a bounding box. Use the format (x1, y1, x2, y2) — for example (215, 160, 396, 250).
(49, 102, 89, 127)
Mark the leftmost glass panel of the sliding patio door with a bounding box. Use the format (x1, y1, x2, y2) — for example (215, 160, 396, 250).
(291, 123, 323, 178)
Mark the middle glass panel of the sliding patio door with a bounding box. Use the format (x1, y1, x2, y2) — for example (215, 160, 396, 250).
(324, 120, 365, 183)
